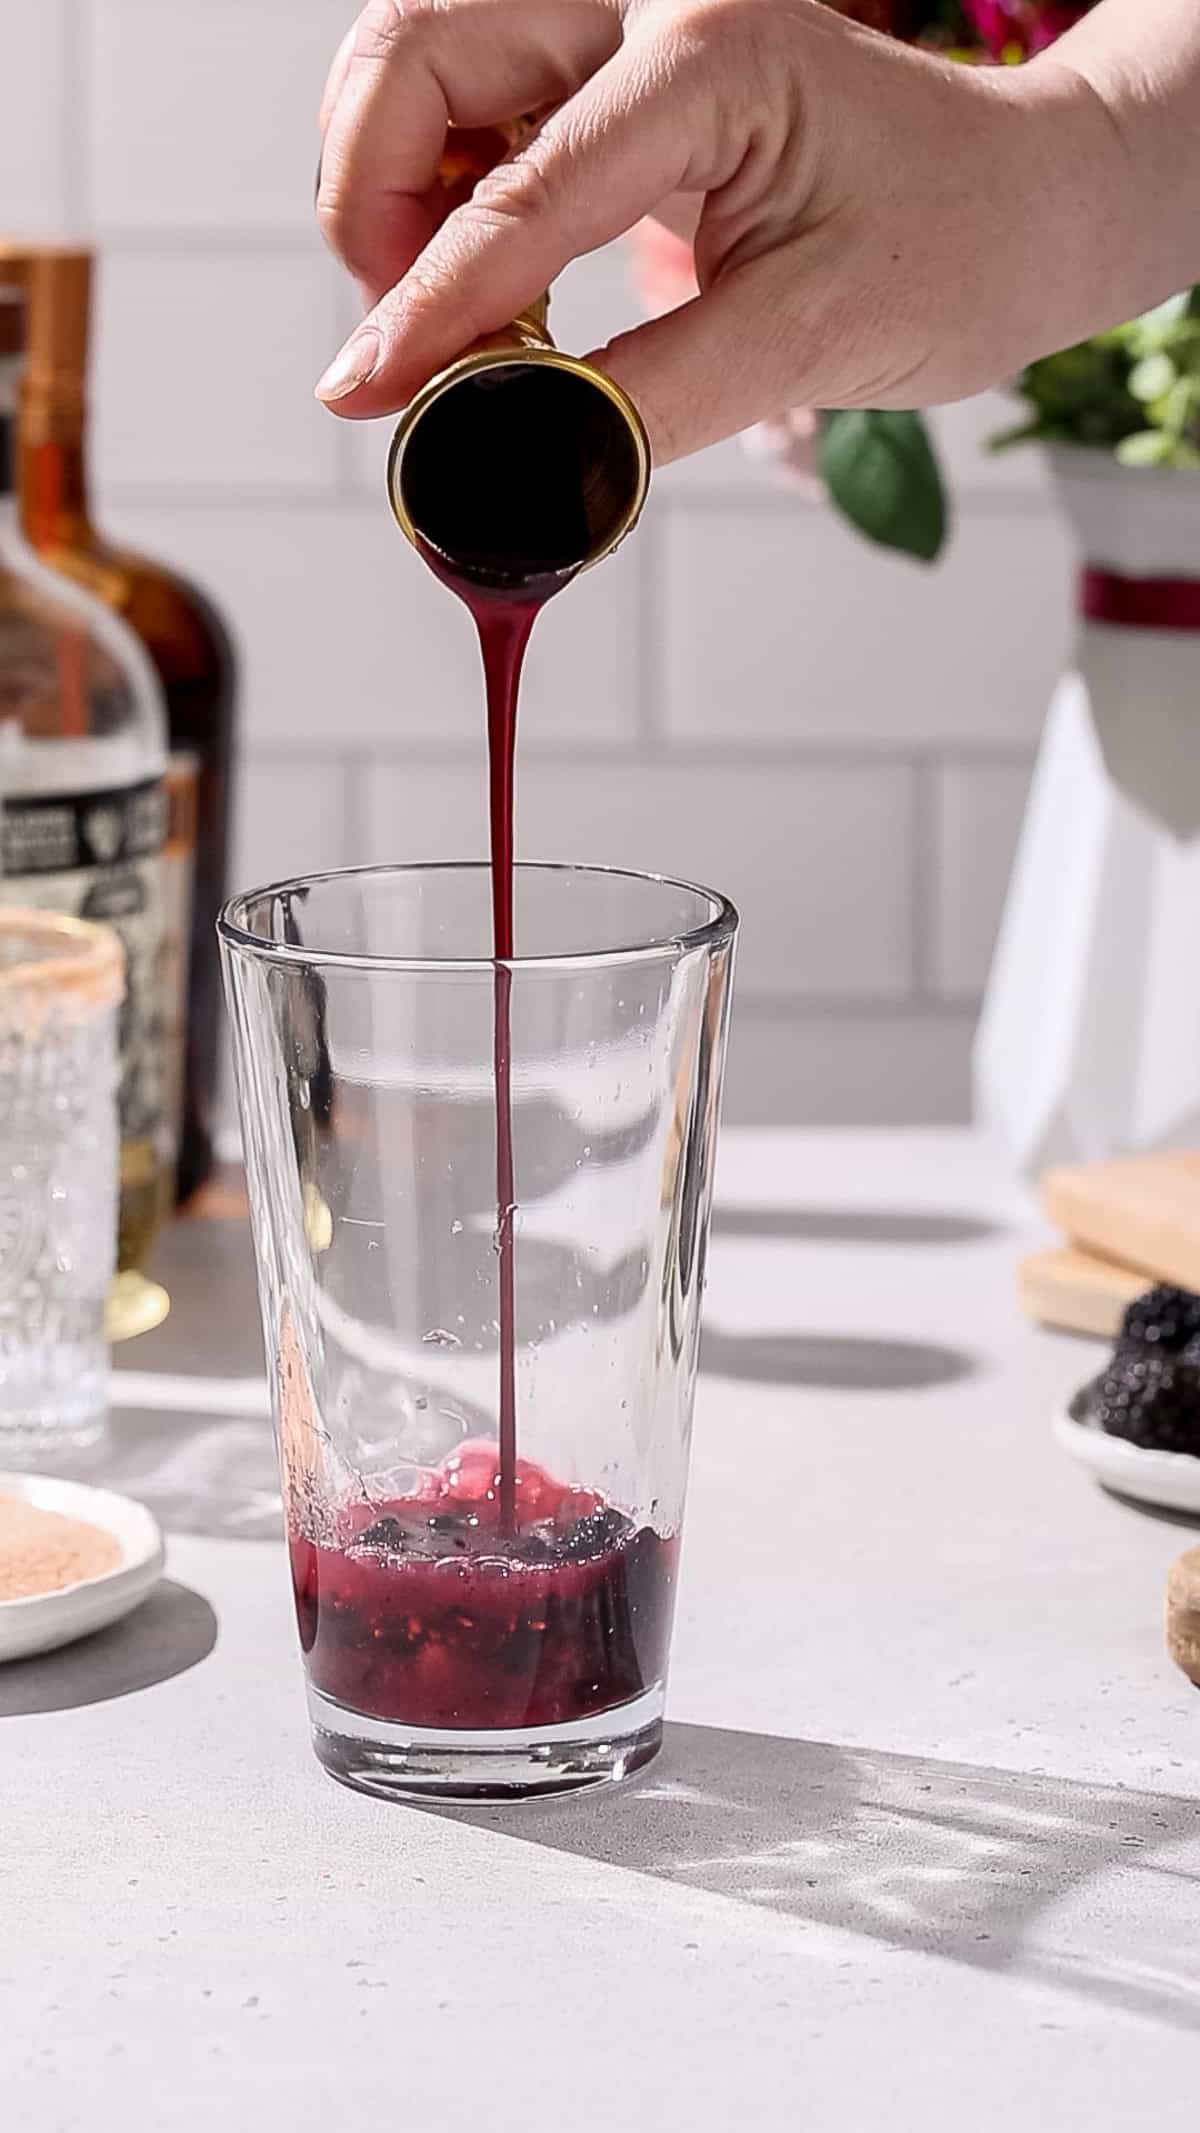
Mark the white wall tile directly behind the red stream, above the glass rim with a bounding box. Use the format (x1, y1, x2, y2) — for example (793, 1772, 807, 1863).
(111, 503, 642, 764)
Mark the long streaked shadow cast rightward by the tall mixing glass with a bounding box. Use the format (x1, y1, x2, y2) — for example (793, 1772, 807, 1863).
(426, 1726, 1200, 2031)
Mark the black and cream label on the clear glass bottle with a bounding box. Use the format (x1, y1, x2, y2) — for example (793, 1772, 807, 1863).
(0, 779, 166, 1141)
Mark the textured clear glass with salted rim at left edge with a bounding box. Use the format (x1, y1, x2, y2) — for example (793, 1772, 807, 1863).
(0, 909, 124, 1465)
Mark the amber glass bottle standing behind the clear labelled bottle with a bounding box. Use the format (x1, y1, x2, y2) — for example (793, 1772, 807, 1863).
(0, 245, 237, 1201)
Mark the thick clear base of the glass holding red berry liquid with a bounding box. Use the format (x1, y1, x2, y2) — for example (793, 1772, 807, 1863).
(309, 1685, 663, 1800)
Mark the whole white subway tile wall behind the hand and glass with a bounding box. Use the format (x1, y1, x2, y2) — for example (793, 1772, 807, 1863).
(0, 0, 1072, 1124)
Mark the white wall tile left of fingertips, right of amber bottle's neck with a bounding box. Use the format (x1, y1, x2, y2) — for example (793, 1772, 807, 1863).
(94, 245, 341, 495)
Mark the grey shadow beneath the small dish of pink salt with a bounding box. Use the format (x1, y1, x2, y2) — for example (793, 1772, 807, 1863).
(0, 1578, 217, 1719)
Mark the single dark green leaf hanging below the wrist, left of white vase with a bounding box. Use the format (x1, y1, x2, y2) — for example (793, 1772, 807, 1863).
(821, 407, 948, 563)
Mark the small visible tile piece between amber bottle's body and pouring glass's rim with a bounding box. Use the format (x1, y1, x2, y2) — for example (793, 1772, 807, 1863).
(230, 753, 354, 894)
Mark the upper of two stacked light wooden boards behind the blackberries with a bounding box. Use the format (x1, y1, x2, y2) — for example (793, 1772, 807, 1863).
(1042, 1154, 1200, 1290)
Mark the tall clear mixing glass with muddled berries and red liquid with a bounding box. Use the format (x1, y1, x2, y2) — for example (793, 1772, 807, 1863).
(222, 866, 737, 1796)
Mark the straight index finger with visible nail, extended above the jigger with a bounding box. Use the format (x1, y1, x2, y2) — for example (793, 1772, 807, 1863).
(318, 45, 701, 416)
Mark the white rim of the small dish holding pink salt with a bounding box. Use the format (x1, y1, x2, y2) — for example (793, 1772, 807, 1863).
(0, 1474, 164, 1662)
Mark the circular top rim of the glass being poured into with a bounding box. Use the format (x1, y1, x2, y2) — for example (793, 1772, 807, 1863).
(217, 860, 740, 977)
